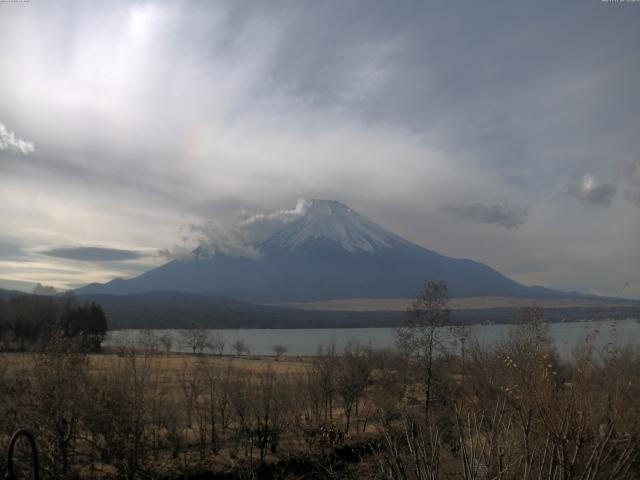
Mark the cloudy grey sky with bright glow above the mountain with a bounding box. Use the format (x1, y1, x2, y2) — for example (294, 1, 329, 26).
(0, 0, 640, 298)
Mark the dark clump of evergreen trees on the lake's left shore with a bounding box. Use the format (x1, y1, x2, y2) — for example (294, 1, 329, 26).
(0, 295, 107, 351)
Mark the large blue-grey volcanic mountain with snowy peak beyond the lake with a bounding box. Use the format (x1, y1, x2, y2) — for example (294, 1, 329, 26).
(76, 200, 575, 303)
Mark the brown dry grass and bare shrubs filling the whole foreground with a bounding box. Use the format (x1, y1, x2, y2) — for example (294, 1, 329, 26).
(0, 289, 640, 480)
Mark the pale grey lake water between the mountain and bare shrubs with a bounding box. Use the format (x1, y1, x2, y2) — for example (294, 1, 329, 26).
(105, 319, 640, 358)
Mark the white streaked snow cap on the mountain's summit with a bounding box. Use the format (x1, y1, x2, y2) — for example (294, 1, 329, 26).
(265, 200, 404, 253)
